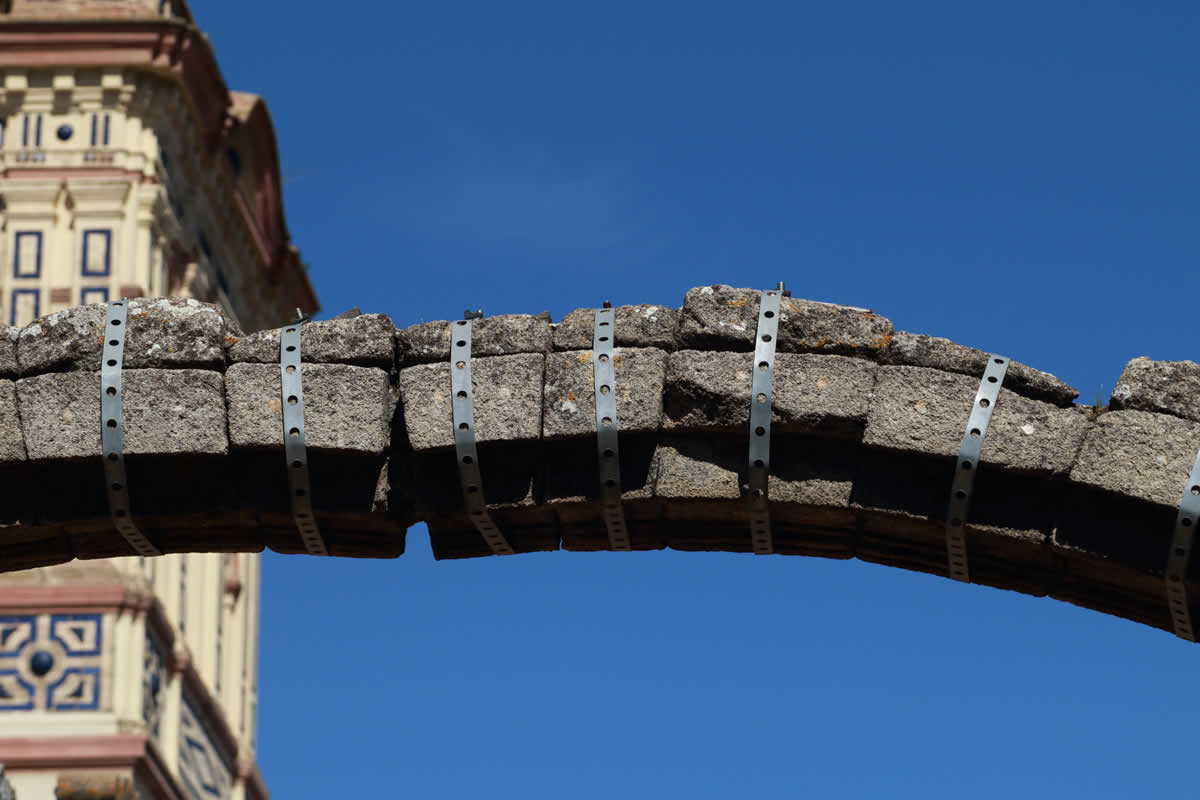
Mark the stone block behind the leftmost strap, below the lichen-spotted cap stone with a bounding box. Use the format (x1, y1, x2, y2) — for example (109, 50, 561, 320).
(17, 367, 228, 455)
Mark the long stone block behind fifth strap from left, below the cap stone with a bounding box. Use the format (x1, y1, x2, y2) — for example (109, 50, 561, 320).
(662, 350, 878, 439)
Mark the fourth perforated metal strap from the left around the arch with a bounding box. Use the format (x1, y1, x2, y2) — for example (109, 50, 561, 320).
(592, 303, 630, 551)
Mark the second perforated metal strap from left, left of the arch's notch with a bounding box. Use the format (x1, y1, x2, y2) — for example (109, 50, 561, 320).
(280, 321, 329, 555)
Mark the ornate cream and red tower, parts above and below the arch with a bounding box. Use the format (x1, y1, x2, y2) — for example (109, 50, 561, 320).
(0, 0, 317, 800)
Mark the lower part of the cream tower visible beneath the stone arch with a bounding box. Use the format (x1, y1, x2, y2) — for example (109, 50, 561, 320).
(0, 553, 265, 800)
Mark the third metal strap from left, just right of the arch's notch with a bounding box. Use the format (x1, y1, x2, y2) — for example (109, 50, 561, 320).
(450, 312, 512, 555)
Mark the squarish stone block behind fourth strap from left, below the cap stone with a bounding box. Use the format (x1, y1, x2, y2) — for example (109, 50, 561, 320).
(544, 348, 666, 439)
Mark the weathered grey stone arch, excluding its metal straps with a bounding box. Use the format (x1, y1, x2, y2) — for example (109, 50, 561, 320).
(0, 285, 1200, 630)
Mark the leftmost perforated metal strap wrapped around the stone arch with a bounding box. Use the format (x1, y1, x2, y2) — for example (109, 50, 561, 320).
(100, 300, 162, 555)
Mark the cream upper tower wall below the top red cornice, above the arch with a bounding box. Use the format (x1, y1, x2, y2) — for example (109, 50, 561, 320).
(0, 66, 309, 330)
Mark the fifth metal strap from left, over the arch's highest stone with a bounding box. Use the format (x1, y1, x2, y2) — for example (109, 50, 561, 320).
(749, 284, 784, 555)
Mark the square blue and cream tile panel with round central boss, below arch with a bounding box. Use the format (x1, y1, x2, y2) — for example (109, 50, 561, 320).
(0, 614, 104, 711)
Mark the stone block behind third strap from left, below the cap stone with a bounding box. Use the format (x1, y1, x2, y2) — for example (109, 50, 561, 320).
(400, 354, 545, 451)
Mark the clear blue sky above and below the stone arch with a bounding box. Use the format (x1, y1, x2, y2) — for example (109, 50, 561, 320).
(201, 0, 1200, 800)
